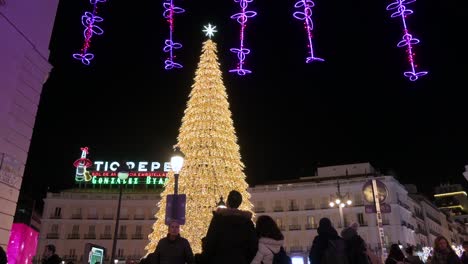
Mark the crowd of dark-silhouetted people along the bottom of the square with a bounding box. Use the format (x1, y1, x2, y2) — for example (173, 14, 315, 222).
(13, 190, 468, 264)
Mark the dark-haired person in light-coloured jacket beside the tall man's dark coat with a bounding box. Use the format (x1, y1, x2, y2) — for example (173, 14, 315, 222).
(251, 215, 284, 264)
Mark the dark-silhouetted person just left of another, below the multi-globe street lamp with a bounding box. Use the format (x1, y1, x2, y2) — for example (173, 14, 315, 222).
(309, 217, 342, 264)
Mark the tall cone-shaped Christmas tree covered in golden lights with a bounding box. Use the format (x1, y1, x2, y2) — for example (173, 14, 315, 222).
(145, 40, 252, 253)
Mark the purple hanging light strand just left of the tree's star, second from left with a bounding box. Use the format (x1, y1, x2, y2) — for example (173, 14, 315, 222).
(163, 0, 185, 70)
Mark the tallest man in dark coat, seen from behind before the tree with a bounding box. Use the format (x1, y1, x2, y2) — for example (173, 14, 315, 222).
(203, 190, 258, 264)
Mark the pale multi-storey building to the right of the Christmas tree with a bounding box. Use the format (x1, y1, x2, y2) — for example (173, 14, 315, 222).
(249, 163, 467, 263)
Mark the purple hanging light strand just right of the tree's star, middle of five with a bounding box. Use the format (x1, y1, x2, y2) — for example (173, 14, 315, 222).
(229, 0, 257, 75)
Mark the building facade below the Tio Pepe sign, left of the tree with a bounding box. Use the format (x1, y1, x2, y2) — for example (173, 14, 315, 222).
(35, 189, 160, 263)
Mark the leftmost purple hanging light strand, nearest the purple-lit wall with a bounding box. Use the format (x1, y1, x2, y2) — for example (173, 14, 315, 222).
(73, 0, 106, 65)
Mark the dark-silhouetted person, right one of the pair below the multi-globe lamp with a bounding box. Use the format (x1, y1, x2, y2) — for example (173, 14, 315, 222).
(341, 223, 370, 264)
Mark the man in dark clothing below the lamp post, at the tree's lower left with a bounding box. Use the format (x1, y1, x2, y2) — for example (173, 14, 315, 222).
(149, 221, 194, 264)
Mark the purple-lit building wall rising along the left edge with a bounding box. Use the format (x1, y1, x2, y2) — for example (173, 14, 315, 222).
(0, 0, 58, 248)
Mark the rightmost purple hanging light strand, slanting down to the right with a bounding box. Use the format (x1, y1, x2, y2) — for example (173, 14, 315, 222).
(387, 0, 428, 81)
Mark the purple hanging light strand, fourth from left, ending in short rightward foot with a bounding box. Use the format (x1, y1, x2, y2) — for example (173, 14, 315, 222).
(293, 0, 324, 63)
